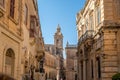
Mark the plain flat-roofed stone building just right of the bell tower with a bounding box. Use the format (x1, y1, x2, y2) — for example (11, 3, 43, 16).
(65, 43, 77, 80)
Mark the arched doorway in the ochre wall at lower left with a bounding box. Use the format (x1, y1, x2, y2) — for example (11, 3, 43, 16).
(5, 48, 15, 77)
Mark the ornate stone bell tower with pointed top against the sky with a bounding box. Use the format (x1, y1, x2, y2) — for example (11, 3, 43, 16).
(54, 24, 63, 57)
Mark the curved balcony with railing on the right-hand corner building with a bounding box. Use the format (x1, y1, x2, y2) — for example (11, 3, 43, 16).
(78, 30, 94, 45)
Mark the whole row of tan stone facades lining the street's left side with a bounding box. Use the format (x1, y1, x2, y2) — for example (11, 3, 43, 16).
(0, 0, 44, 80)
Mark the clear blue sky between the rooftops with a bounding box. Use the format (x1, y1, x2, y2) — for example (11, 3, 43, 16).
(38, 0, 86, 57)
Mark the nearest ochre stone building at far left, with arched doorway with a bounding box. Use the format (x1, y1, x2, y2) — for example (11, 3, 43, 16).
(0, 0, 23, 79)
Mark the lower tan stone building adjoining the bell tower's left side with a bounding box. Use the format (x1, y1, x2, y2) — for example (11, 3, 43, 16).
(44, 44, 58, 80)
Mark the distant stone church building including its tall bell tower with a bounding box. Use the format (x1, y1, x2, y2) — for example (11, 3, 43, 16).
(44, 25, 64, 80)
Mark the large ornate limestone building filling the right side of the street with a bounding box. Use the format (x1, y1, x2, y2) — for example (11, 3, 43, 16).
(76, 0, 120, 80)
